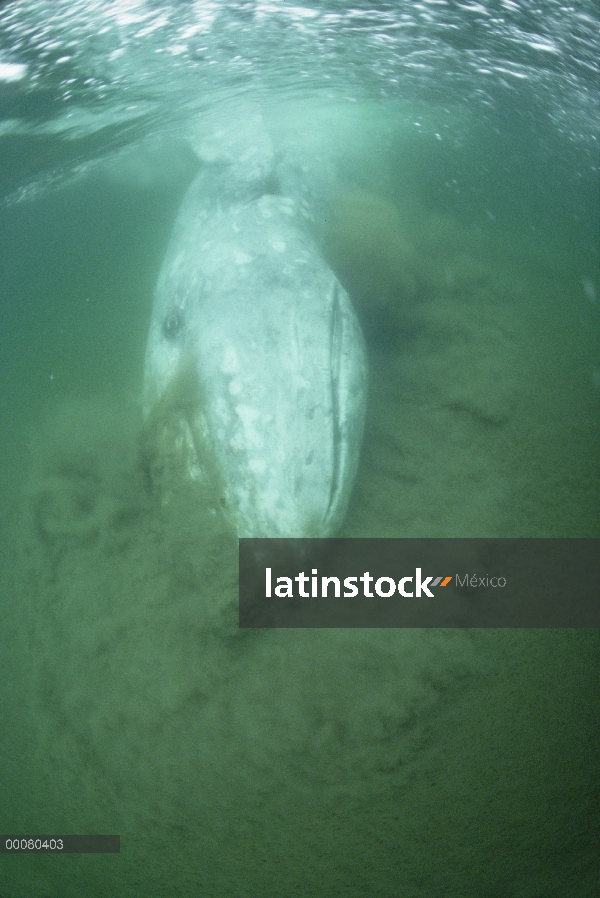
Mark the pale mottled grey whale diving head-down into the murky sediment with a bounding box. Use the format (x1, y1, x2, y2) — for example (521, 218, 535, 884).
(144, 166, 367, 538)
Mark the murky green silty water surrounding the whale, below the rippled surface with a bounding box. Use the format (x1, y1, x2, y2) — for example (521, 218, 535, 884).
(0, 103, 600, 898)
